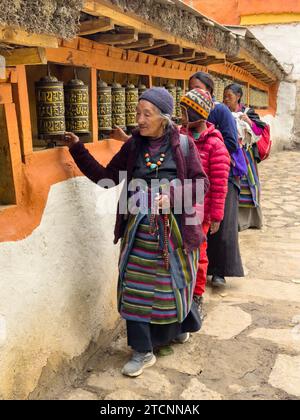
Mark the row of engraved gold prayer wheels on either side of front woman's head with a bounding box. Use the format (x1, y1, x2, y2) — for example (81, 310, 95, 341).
(36, 74, 183, 138)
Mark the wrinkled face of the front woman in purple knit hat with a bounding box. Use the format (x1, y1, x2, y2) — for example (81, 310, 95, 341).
(136, 99, 164, 138)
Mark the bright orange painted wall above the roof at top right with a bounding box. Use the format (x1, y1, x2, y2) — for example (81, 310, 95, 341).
(184, 0, 300, 25)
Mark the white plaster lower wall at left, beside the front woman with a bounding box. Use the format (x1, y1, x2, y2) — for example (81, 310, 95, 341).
(0, 177, 120, 398)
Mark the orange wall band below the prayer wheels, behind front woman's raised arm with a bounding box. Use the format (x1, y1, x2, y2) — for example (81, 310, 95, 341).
(0, 140, 123, 242)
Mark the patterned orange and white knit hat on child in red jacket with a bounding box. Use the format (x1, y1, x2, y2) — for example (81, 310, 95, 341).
(180, 88, 213, 120)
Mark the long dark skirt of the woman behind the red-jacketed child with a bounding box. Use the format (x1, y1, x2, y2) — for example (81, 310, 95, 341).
(207, 182, 244, 277)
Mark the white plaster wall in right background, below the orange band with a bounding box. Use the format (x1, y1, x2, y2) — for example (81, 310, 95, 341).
(249, 23, 300, 150)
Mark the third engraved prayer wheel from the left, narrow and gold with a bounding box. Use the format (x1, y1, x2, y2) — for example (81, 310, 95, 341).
(97, 79, 112, 133)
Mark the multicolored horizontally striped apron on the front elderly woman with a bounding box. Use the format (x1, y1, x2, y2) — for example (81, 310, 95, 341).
(119, 215, 199, 325)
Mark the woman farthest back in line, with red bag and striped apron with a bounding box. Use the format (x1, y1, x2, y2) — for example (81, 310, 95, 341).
(224, 83, 266, 231)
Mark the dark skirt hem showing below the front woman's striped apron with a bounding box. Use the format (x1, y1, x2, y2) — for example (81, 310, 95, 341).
(126, 302, 201, 352)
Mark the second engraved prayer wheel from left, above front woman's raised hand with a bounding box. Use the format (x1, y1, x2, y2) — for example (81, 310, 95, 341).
(65, 79, 90, 134)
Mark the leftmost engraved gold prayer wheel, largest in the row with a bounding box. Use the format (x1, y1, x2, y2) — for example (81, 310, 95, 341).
(35, 75, 66, 137)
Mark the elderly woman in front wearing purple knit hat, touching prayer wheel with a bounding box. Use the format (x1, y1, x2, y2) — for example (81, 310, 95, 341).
(65, 88, 208, 377)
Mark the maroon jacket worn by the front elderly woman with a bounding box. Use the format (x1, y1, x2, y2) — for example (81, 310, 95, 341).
(70, 129, 209, 251)
